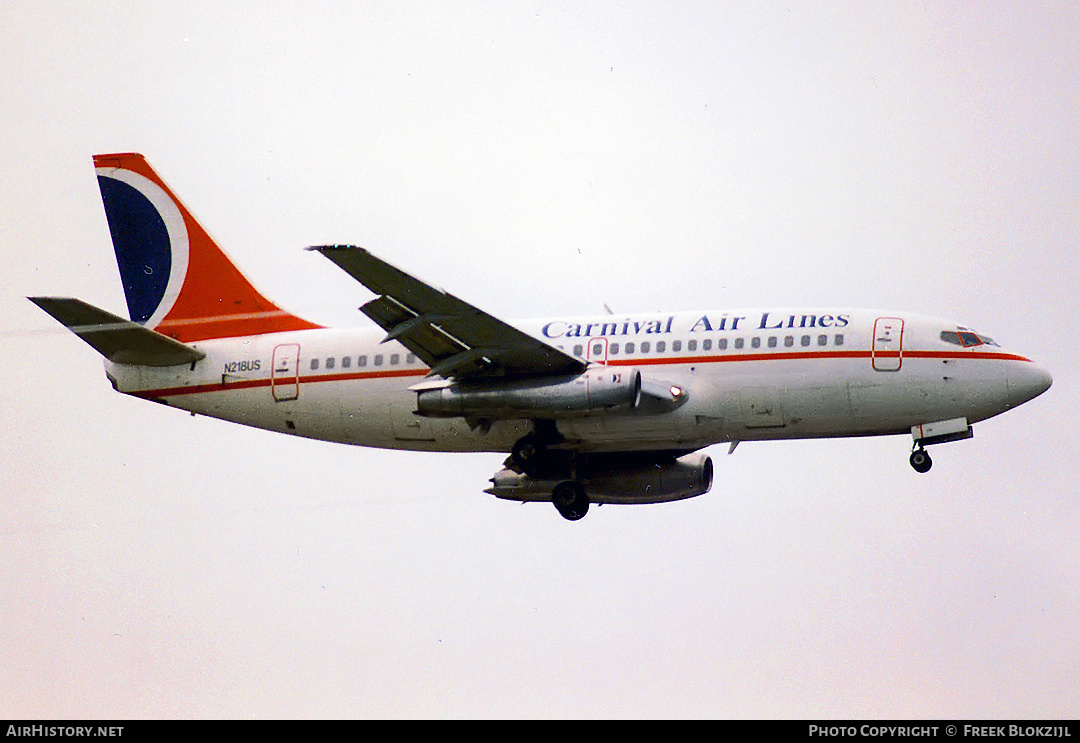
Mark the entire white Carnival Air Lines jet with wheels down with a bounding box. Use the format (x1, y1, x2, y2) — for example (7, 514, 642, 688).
(29, 153, 1052, 521)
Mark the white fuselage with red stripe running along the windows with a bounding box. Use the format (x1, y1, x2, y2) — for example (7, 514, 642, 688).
(107, 309, 1049, 451)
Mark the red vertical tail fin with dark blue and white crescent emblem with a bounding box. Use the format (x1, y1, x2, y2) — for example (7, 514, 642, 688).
(91, 152, 319, 342)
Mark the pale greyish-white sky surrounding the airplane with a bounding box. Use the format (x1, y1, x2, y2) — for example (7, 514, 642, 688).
(0, 0, 1080, 718)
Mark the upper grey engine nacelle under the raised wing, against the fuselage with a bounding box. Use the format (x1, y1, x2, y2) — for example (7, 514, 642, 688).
(416, 367, 642, 418)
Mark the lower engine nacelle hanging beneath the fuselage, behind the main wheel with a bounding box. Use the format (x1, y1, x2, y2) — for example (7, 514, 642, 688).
(486, 454, 713, 503)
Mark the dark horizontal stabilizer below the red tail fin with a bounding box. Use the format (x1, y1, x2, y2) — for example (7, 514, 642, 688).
(28, 297, 206, 366)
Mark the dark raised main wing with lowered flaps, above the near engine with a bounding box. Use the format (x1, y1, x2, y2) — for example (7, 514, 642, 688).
(308, 245, 586, 379)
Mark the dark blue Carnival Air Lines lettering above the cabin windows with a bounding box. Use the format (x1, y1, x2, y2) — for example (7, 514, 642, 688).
(542, 311, 851, 338)
